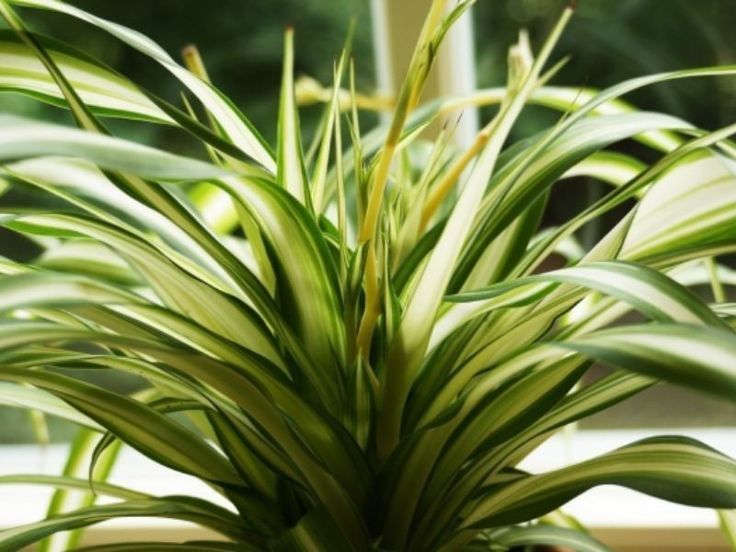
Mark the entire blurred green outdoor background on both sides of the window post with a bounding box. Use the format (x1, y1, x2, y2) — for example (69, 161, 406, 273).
(0, 0, 736, 442)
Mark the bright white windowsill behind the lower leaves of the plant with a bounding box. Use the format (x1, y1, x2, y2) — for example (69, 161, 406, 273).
(0, 428, 736, 550)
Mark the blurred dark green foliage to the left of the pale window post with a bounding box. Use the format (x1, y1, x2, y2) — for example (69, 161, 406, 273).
(0, 0, 374, 149)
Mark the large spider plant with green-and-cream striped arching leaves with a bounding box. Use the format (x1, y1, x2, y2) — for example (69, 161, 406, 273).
(0, 0, 736, 551)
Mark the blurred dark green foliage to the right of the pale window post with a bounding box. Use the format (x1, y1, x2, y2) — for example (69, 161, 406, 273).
(475, 0, 736, 133)
